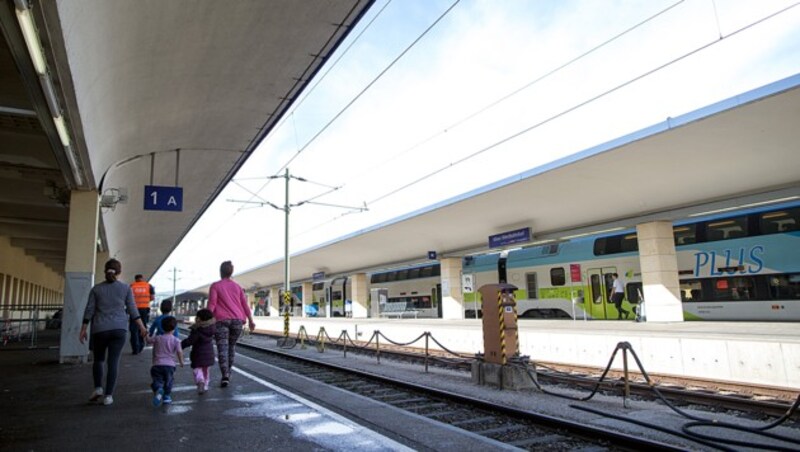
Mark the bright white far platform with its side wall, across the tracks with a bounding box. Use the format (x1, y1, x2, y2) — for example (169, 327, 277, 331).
(250, 317, 800, 390)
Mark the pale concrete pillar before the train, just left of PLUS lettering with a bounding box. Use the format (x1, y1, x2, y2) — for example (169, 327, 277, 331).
(636, 221, 683, 322)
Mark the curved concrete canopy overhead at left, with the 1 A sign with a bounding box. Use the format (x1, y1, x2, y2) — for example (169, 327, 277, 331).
(0, 0, 372, 275)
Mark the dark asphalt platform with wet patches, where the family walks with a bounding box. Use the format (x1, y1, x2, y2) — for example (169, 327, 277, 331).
(0, 330, 411, 451)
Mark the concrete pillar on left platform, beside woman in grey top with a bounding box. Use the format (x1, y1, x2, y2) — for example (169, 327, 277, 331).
(59, 191, 99, 363)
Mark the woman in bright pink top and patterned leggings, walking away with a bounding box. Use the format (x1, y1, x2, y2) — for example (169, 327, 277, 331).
(208, 261, 256, 388)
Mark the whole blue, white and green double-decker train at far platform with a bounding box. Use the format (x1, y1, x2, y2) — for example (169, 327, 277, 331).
(296, 203, 800, 321)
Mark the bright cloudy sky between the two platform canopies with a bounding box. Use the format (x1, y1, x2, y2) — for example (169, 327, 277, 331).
(151, 0, 800, 295)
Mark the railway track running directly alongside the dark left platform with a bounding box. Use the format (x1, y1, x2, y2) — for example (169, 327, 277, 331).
(238, 342, 684, 451)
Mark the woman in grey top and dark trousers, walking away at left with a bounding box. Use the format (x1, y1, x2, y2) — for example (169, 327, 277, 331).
(79, 259, 147, 405)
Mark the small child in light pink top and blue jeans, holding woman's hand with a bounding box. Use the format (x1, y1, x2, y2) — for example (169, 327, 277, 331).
(147, 317, 183, 406)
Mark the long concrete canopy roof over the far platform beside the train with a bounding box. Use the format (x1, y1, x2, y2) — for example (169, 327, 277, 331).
(223, 75, 800, 290)
